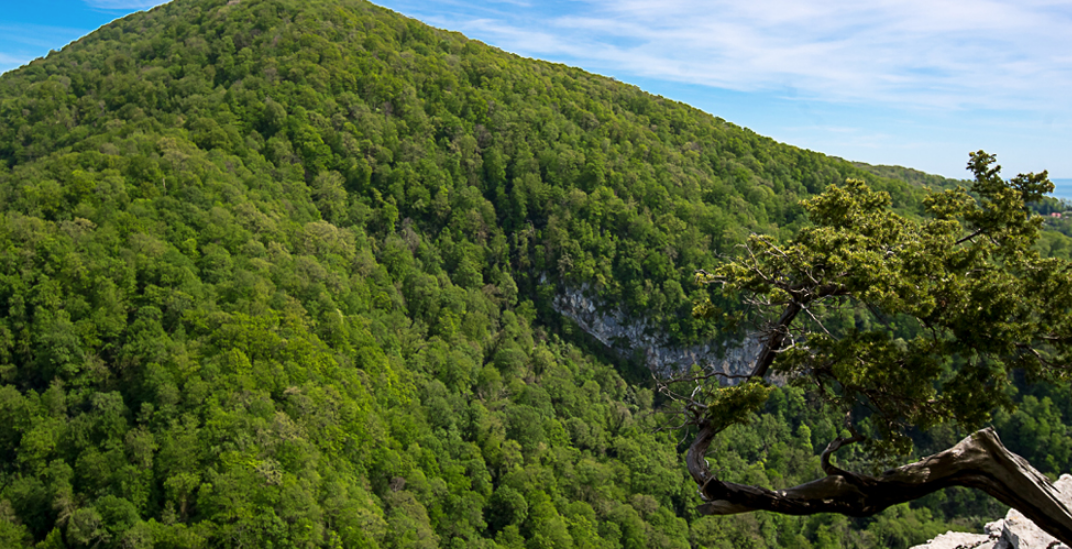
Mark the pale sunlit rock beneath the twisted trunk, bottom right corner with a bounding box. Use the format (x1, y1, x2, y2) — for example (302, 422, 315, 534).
(912, 475, 1072, 549)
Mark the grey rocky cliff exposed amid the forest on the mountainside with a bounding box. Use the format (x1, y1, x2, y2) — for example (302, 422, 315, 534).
(553, 285, 760, 375)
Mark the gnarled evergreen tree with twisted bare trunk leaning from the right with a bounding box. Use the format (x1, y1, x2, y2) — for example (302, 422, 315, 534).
(677, 151, 1072, 544)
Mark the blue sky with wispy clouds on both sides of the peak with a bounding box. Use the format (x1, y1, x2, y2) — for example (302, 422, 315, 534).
(0, 0, 1072, 178)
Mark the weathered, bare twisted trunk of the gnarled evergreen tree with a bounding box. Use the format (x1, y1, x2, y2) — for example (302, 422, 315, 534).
(686, 426, 1072, 545)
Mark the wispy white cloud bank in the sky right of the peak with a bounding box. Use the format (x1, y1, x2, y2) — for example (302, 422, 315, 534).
(430, 0, 1072, 110)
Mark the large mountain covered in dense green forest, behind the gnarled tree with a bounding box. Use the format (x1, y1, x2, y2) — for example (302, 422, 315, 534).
(0, 0, 1072, 549)
